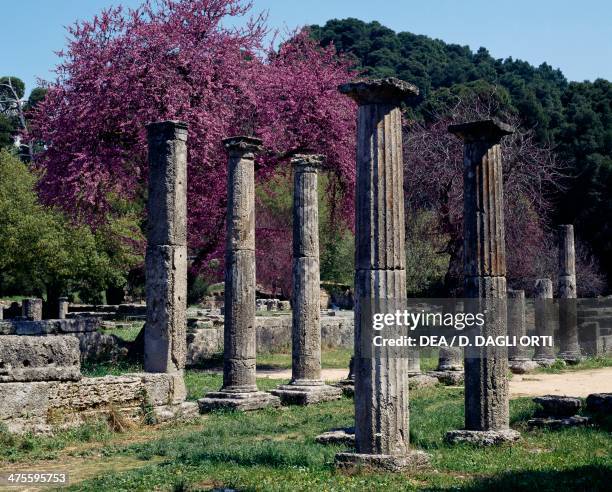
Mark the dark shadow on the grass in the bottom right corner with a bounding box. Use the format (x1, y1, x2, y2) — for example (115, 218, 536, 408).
(438, 465, 612, 492)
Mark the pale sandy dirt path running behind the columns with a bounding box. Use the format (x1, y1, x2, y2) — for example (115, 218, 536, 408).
(257, 367, 612, 397)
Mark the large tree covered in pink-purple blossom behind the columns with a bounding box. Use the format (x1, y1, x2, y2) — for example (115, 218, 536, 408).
(29, 0, 355, 290)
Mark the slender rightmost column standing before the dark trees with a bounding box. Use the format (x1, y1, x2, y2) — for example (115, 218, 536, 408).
(558, 225, 581, 364)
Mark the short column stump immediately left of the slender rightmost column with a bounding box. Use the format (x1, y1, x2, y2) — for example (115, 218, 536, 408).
(533, 278, 555, 367)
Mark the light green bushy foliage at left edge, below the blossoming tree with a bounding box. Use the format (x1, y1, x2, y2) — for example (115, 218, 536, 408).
(0, 151, 137, 301)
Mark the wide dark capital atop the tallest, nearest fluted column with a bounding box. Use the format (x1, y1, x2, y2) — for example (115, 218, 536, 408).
(338, 77, 419, 105)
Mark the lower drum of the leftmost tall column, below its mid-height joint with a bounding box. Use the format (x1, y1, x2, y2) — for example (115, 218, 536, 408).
(144, 246, 187, 372)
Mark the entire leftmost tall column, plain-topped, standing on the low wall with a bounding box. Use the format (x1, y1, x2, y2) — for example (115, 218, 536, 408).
(144, 121, 187, 385)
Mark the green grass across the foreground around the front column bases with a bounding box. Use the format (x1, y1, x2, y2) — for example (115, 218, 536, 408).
(0, 371, 612, 492)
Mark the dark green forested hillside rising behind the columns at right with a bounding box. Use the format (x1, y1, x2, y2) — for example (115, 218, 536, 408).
(311, 19, 612, 286)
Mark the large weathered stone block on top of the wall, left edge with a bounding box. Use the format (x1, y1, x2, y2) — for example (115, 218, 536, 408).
(0, 335, 81, 383)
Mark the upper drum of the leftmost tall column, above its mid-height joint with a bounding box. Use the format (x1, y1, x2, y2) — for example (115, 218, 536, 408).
(147, 121, 187, 246)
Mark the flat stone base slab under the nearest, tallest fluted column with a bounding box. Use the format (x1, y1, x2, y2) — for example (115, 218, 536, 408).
(335, 450, 429, 472)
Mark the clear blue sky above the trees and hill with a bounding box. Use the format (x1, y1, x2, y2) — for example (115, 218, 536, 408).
(0, 0, 612, 92)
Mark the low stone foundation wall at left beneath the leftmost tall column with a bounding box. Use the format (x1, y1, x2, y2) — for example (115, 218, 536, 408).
(0, 373, 192, 433)
